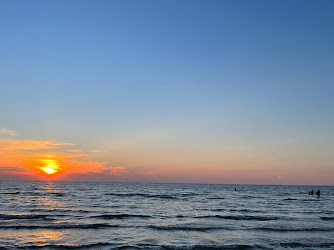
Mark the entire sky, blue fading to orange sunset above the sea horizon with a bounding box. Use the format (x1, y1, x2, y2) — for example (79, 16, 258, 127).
(0, 0, 334, 185)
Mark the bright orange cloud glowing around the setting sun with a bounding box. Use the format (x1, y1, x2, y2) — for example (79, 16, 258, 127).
(0, 139, 127, 180)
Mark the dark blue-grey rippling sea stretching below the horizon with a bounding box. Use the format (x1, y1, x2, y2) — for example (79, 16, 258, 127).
(0, 182, 334, 249)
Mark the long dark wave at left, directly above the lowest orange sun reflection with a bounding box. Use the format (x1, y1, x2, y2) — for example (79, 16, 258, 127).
(0, 223, 118, 229)
